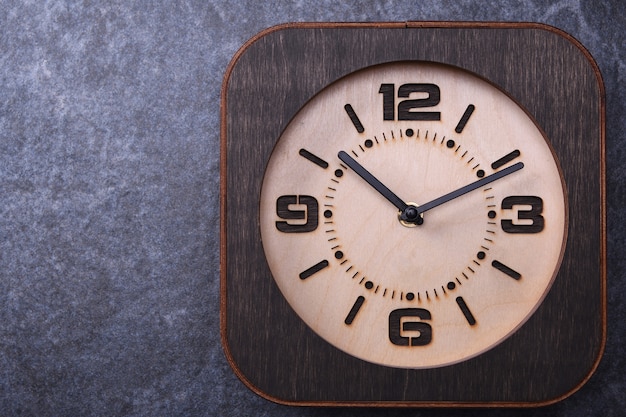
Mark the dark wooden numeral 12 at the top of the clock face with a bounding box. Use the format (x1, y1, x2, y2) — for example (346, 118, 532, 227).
(378, 84, 441, 120)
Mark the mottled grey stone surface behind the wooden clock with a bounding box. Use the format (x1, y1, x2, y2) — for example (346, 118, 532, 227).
(0, 0, 626, 417)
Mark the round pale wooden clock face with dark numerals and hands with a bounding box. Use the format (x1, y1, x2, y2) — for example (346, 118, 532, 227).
(260, 62, 567, 368)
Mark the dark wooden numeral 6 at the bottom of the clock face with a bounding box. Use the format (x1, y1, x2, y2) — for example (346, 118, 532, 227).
(389, 308, 433, 346)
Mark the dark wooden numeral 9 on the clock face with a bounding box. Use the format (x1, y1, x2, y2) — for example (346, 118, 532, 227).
(276, 195, 318, 233)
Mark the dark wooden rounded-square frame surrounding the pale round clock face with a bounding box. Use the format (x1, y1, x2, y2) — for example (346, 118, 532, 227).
(220, 22, 606, 407)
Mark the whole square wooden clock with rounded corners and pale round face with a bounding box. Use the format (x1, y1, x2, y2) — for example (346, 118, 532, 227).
(221, 23, 606, 406)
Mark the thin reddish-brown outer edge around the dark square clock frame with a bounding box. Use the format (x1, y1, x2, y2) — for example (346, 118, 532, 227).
(219, 21, 607, 408)
